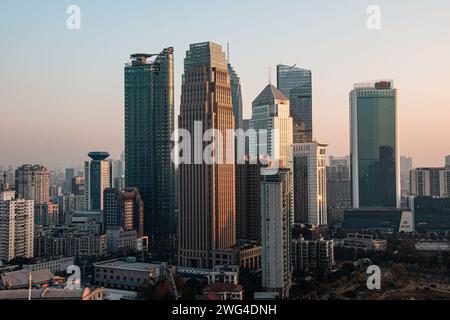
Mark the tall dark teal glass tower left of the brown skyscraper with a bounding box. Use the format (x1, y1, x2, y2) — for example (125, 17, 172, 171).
(125, 48, 176, 245)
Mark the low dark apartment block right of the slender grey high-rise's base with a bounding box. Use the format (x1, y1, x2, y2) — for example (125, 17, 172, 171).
(294, 238, 334, 273)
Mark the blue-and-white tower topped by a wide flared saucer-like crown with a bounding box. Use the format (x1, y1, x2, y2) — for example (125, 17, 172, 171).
(84, 151, 112, 211)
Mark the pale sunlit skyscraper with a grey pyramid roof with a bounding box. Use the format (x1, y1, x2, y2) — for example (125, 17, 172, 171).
(250, 84, 293, 167)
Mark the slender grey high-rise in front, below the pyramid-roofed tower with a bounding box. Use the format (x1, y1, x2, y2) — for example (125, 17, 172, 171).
(261, 169, 293, 297)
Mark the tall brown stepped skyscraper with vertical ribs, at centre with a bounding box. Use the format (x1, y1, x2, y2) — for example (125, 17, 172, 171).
(178, 42, 236, 268)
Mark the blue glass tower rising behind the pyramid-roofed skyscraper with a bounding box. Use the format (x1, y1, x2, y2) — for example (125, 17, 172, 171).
(277, 64, 313, 143)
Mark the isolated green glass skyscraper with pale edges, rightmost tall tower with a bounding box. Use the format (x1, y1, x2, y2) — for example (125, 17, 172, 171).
(350, 81, 400, 209)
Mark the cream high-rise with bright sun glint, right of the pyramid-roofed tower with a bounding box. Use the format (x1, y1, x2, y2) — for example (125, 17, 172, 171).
(294, 142, 328, 225)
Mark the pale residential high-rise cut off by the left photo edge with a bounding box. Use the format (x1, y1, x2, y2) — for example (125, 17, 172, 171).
(0, 190, 34, 261)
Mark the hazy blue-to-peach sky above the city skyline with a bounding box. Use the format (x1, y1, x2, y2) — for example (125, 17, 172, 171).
(0, 0, 450, 167)
